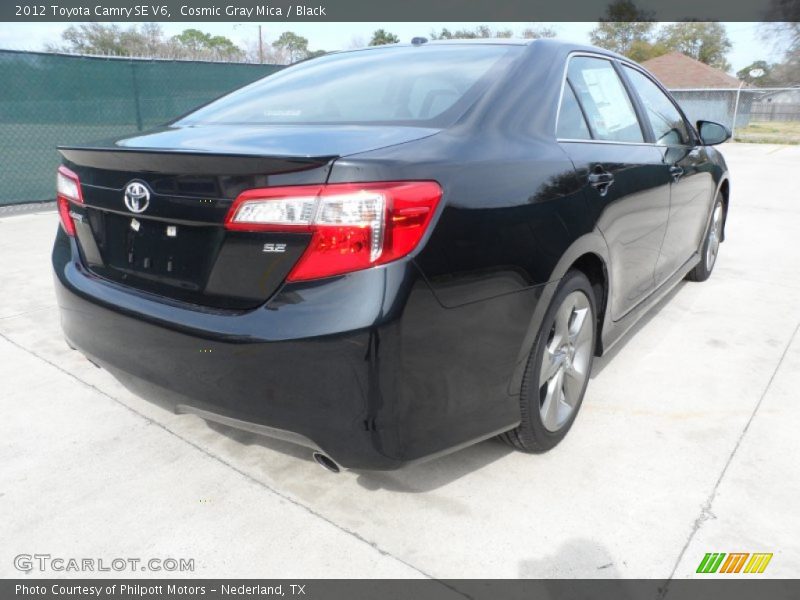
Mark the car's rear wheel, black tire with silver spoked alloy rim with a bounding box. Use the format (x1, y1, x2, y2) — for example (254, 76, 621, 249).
(500, 271, 597, 452)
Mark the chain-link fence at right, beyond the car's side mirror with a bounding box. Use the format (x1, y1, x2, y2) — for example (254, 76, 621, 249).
(671, 87, 800, 144)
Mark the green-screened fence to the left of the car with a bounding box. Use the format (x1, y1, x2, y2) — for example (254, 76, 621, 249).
(0, 50, 281, 206)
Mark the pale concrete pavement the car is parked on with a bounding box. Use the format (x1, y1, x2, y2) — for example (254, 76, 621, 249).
(0, 144, 800, 579)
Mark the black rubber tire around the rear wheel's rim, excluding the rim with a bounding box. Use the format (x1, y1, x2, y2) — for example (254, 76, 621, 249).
(500, 271, 597, 453)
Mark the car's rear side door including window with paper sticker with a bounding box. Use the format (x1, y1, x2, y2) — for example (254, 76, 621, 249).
(556, 54, 670, 320)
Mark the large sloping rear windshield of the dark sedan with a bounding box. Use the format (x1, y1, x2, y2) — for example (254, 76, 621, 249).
(177, 45, 523, 125)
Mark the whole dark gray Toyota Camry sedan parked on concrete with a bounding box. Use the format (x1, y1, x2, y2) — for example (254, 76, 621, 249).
(53, 40, 729, 470)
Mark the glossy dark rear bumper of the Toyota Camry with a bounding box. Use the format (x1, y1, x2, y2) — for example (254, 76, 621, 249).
(53, 232, 541, 469)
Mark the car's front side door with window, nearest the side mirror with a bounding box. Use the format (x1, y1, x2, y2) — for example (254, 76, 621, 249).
(623, 65, 715, 285)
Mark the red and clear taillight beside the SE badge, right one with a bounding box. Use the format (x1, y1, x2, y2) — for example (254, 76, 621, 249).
(225, 181, 442, 281)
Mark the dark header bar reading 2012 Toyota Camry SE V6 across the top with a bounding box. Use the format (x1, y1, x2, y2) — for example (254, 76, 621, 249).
(0, 0, 800, 23)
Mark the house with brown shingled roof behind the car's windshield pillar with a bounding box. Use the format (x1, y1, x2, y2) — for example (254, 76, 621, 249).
(642, 52, 755, 128)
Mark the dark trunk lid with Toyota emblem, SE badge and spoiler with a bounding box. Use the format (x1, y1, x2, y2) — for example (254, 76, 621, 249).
(59, 126, 434, 310)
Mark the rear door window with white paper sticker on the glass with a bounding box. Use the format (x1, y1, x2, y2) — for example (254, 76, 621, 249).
(567, 56, 644, 142)
